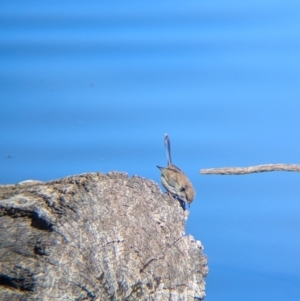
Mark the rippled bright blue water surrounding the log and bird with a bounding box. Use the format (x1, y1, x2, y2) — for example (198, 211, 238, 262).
(0, 0, 300, 301)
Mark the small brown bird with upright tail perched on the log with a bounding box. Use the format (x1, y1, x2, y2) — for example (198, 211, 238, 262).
(157, 134, 196, 209)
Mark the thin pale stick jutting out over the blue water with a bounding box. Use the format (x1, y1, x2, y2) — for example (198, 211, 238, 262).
(200, 164, 300, 175)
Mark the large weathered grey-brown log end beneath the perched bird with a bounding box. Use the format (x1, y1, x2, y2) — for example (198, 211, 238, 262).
(0, 173, 208, 301)
